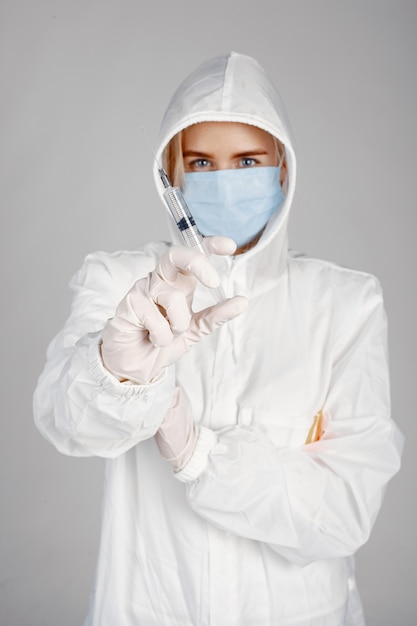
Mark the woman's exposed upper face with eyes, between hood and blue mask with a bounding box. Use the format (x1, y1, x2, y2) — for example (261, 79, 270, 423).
(182, 122, 285, 182)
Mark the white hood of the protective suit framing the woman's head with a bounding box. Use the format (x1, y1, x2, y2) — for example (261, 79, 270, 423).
(154, 52, 296, 296)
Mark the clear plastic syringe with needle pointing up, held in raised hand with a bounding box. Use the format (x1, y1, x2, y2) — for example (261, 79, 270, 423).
(158, 167, 226, 302)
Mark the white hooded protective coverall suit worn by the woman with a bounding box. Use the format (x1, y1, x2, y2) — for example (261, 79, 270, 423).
(35, 53, 402, 626)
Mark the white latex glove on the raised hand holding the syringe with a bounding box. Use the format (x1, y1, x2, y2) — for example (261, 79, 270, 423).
(101, 237, 247, 384)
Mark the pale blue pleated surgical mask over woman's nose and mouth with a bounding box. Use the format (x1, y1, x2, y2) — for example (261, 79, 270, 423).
(183, 167, 284, 248)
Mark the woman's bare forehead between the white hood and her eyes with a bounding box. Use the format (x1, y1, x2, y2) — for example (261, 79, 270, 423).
(183, 122, 275, 149)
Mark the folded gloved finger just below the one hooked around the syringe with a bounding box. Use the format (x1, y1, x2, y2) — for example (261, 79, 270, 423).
(149, 277, 191, 334)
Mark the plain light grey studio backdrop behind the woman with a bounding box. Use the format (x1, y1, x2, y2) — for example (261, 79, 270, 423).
(0, 0, 417, 626)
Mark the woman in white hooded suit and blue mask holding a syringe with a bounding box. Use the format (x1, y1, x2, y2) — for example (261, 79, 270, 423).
(35, 53, 401, 626)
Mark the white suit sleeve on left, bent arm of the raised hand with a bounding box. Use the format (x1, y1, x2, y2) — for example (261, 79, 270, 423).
(34, 253, 174, 458)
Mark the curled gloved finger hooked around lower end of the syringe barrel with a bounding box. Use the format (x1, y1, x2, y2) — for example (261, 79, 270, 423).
(156, 246, 220, 287)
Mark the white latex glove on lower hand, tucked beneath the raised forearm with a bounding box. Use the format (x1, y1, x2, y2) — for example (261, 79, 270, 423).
(155, 387, 199, 472)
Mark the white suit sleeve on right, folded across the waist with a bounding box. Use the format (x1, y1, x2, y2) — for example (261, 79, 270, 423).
(177, 278, 402, 565)
